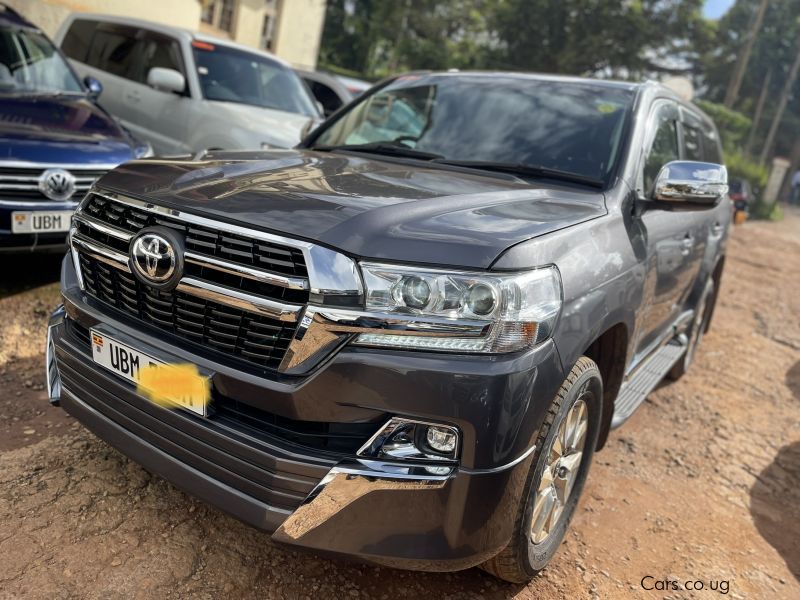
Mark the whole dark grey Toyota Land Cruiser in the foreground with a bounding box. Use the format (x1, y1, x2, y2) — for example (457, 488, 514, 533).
(47, 72, 731, 581)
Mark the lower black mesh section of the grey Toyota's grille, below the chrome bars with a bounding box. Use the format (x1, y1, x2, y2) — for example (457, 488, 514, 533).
(80, 254, 295, 369)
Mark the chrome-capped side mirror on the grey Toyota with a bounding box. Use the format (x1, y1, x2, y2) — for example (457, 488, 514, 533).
(653, 160, 728, 207)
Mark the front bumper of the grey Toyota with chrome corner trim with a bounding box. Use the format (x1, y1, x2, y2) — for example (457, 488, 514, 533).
(49, 259, 563, 570)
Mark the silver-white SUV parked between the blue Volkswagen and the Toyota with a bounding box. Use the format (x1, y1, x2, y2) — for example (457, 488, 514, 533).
(55, 13, 321, 155)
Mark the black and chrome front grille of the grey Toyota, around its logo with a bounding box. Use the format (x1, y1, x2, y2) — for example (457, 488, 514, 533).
(72, 193, 309, 370)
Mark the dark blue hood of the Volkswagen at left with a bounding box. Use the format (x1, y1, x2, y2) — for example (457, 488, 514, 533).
(0, 96, 133, 165)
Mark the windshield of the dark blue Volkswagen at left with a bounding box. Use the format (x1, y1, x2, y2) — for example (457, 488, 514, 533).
(0, 29, 83, 94)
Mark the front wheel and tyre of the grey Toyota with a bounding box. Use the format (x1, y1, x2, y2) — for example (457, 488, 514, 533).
(480, 356, 603, 583)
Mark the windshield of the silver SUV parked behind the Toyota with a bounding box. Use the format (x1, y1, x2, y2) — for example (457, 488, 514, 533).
(193, 42, 319, 117)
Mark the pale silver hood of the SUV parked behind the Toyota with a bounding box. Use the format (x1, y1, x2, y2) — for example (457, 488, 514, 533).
(207, 100, 312, 150)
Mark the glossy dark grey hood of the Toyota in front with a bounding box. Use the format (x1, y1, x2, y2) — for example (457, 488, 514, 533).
(99, 150, 606, 269)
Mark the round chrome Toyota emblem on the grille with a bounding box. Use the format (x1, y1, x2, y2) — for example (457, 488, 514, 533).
(130, 227, 183, 289)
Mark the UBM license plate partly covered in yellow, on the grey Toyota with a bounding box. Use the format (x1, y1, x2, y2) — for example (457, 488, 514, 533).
(91, 330, 207, 417)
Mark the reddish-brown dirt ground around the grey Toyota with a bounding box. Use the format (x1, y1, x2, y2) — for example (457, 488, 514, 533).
(0, 212, 800, 599)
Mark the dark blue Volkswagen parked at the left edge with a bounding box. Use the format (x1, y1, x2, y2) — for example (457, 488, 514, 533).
(0, 4, 150, 252)
